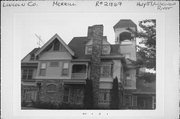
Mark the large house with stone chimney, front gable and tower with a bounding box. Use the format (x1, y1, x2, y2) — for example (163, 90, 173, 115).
(21, 20, 155, 108)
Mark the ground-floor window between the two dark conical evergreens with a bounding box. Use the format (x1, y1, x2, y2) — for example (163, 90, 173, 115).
(99, 89, 110, 103)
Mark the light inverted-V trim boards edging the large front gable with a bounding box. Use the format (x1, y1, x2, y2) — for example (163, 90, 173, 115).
(36, 34, 74, 56)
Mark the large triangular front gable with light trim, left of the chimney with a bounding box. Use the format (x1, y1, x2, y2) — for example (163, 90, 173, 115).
(35, 34, 74, 60)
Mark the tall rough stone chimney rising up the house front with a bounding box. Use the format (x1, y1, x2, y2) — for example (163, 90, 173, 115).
(89, 25, 103, 108)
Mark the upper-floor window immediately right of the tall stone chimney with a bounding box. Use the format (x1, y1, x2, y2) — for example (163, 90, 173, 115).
(101, 64, 112, 77)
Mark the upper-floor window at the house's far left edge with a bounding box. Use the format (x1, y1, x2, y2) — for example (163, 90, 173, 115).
(22, 69, 33, 80)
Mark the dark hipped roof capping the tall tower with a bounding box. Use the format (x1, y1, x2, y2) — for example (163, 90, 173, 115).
(113, 19, 137, 29)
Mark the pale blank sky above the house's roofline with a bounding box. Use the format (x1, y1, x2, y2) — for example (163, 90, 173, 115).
(14, 12, 142, 58)
